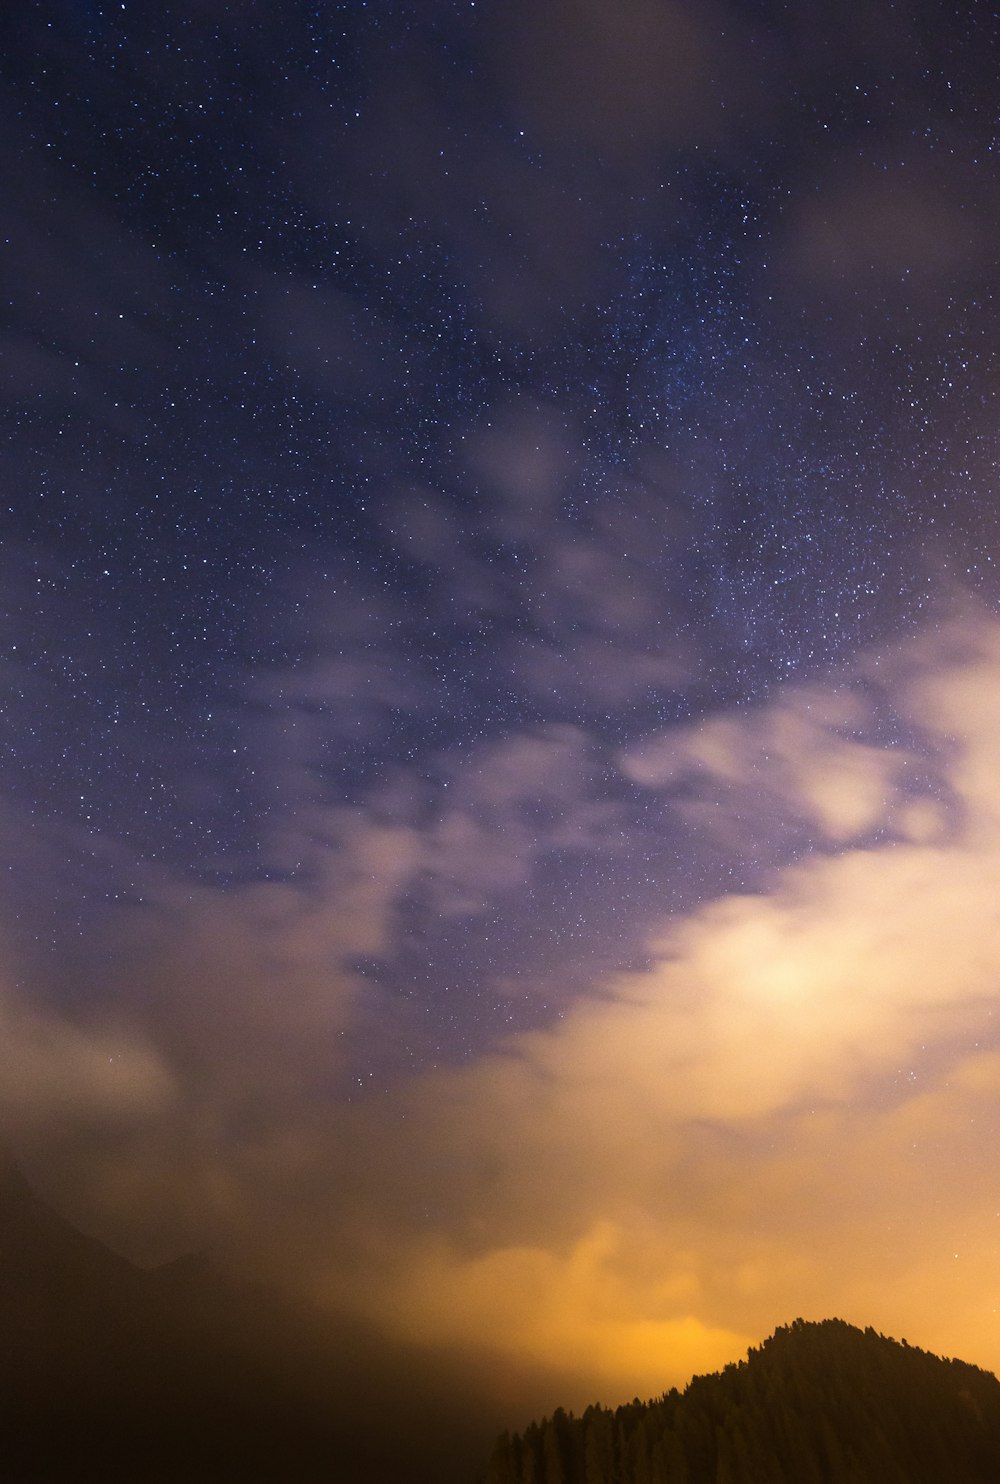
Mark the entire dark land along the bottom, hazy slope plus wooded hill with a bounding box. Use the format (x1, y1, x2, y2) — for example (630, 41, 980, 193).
(0, 1153, 1000, 1484)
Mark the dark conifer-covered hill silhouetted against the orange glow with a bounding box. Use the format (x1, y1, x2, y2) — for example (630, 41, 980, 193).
(487, 1319, 1000, 1484)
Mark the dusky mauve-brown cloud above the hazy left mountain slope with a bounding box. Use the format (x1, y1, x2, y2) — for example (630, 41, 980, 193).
(0, 807, 418, 1261)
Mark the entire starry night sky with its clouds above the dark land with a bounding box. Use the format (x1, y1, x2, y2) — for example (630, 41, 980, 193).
(0, 0, 1000, 1460)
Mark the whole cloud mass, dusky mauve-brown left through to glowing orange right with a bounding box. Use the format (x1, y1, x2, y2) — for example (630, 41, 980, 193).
(11, 614, 1000, 1405)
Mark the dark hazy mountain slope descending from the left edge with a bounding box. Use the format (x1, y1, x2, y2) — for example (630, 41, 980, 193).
(0, 1150, 497, 1484)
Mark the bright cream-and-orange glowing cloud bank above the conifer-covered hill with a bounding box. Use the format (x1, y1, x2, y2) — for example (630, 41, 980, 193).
(287, 625, 1000, 1402)
